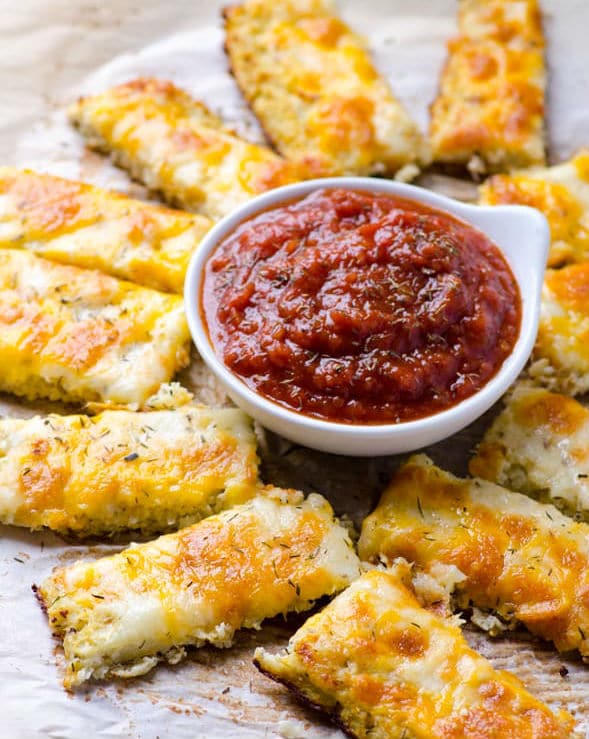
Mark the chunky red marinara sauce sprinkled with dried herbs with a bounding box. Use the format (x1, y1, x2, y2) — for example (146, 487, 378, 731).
(200, 189, 521, 424)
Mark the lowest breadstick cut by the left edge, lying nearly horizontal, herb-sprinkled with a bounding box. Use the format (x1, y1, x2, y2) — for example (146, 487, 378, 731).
(0, 404, 258, 536)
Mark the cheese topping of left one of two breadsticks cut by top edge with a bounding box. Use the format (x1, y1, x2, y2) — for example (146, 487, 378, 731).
(225, 0, 428, 176)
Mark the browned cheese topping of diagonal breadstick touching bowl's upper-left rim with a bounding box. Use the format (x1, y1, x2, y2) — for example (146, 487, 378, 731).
(70, 78, 299, 218)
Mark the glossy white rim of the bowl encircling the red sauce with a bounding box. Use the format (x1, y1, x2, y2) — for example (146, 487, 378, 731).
(184, 177, 549, 448)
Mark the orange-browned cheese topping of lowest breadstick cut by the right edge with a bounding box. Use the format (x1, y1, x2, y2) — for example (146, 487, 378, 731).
(359, 456, 589, 655)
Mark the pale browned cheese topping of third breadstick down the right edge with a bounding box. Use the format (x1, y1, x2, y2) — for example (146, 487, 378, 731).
(470, 385, 589, 520)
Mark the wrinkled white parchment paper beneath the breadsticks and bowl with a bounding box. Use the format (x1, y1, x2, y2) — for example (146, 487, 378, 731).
(0, 0, 589, 739)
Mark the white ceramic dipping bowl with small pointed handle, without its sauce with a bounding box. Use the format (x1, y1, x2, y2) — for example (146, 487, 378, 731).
(184, 177, 549, 456)
